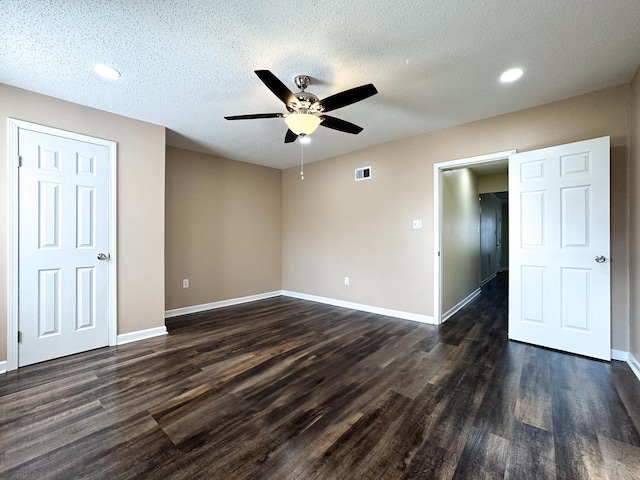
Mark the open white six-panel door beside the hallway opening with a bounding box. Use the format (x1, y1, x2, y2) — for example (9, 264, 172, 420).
(509, 137, 611, 360)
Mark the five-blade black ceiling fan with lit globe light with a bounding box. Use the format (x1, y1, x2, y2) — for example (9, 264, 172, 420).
(224, 70, 378, 143)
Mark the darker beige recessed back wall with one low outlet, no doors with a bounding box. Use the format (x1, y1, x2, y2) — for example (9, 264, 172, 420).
(165, 147, 282, 310)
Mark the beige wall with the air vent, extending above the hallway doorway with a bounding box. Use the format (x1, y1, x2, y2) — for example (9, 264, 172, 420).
(282, 85, 629, 350)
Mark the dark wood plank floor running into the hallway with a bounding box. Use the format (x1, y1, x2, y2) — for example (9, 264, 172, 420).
(0, 275, 640, 480)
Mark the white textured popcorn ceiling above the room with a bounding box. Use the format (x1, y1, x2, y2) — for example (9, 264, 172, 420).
(0, 0, 640, 168)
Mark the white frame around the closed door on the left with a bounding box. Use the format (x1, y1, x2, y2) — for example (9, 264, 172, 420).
(7, 118, 118, 370)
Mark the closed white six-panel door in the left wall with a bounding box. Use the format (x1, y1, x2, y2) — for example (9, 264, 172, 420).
(18, 129, 109, 366)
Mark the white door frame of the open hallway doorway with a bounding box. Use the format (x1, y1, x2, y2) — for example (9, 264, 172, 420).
(433, 150, 516, 325)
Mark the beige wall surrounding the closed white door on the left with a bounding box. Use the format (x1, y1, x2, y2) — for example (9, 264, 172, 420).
(0, 84, 165, 360)
